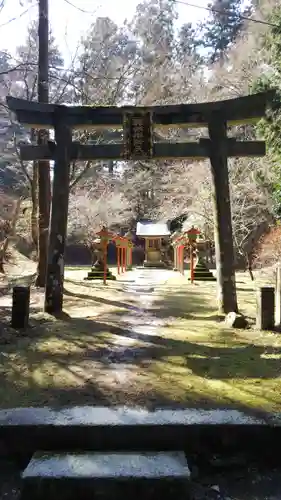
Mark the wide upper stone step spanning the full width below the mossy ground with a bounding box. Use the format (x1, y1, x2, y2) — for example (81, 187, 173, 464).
(0, 406, 276, 455)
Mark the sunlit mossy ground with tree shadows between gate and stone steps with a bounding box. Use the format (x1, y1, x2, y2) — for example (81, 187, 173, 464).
(0, 269, 281, 412)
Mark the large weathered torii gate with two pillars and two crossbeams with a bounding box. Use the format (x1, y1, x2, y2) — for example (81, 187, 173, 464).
(7, 92, 271, 313)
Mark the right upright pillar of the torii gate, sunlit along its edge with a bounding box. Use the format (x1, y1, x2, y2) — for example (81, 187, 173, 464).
(208, 113, 238, 314)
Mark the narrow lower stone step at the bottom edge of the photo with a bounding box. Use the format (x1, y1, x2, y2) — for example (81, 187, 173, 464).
(21, 452, 190, 500)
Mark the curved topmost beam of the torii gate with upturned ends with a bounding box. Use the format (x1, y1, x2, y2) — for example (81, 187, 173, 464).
(7, 92, 273, 129)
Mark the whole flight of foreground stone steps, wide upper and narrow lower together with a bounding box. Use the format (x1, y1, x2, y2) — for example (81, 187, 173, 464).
(10, 407, 281, 500)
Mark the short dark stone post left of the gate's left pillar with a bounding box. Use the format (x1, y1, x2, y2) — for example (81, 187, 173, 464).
(11, 286, 30, 329)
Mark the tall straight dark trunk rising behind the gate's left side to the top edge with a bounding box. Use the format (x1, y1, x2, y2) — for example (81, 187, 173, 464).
(36, 0, 51, 287)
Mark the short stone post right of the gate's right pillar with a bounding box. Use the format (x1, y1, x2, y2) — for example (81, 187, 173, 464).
(256, 287, 275, 330)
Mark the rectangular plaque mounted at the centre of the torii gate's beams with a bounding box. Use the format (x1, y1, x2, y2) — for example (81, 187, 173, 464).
(123, 109, 153, 160)
